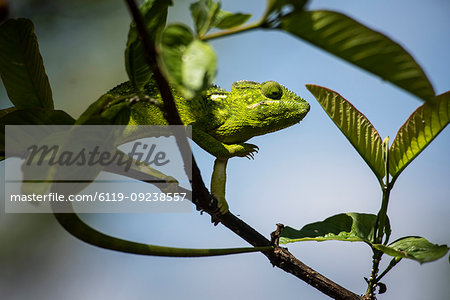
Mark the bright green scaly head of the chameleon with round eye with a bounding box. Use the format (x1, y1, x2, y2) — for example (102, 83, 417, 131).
(215, 81, 309, 142)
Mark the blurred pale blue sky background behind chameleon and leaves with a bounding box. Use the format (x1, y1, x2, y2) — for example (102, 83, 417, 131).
(0, 0, 450, 299)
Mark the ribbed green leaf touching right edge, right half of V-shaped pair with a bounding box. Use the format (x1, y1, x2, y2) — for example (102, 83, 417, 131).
(389, 91, 450, 180)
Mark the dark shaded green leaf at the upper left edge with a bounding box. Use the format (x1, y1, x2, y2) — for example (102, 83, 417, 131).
(0, 19, 53, 109)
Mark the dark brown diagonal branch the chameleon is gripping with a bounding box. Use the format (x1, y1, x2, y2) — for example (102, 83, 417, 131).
(125, 0, 362, 299)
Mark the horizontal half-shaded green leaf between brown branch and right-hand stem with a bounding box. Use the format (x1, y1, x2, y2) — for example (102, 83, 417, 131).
(280, 213, 390, 244)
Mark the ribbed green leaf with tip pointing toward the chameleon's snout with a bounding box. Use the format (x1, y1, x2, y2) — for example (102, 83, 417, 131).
(306, 84, 385, 182)
